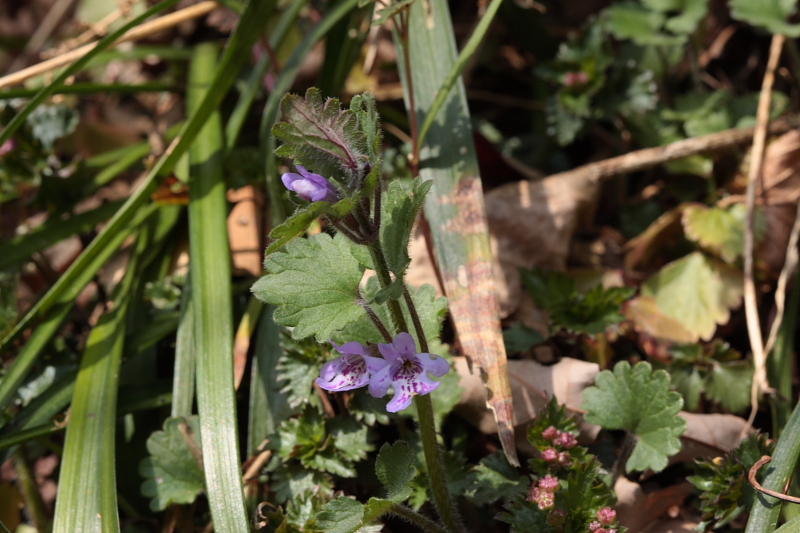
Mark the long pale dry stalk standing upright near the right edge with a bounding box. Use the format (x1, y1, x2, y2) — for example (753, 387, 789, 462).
(744, 34, 786, 431)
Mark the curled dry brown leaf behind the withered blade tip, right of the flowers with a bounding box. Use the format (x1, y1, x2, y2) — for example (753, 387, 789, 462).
(455, 357, 600, 442)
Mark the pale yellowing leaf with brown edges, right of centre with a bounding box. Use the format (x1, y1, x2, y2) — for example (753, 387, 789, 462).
(641, 252, 743, 340)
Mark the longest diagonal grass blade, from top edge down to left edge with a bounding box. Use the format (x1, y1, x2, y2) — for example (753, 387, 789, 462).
(0, 0, 274, 352)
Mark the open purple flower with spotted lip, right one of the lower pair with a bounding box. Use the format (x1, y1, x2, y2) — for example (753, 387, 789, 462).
(369, 333, 450, 413)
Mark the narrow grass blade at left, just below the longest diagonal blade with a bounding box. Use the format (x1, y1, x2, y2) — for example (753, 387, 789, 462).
(0, 206, 155, 411)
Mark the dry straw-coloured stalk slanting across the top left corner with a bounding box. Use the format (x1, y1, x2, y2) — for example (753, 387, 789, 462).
(0, 1, 219, 89)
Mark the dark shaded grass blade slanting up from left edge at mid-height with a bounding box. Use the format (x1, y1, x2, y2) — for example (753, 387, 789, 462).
(0, 201, 122, 270)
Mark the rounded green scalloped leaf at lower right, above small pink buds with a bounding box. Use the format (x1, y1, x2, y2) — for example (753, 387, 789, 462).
(583, 361, 686, 472)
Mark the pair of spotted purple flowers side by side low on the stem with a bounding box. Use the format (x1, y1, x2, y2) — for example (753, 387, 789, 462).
(317, 333, 450, 413)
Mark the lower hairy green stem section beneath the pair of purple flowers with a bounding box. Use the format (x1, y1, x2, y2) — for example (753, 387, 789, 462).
(414, 394, 464, 533)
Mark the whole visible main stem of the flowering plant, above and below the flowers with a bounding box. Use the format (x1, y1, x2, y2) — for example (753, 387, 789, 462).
(369, 242, 463, 533)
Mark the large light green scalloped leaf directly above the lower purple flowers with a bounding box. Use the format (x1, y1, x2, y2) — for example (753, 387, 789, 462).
(252, 233, 365, 342)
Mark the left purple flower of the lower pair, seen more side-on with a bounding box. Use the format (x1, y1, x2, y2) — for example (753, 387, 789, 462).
(317, 342, 388, 391)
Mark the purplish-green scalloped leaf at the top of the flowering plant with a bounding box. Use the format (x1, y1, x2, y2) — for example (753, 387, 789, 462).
(272, 87, 374, 190)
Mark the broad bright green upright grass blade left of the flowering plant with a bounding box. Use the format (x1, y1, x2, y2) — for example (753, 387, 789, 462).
(188, 44, 249, 533)
